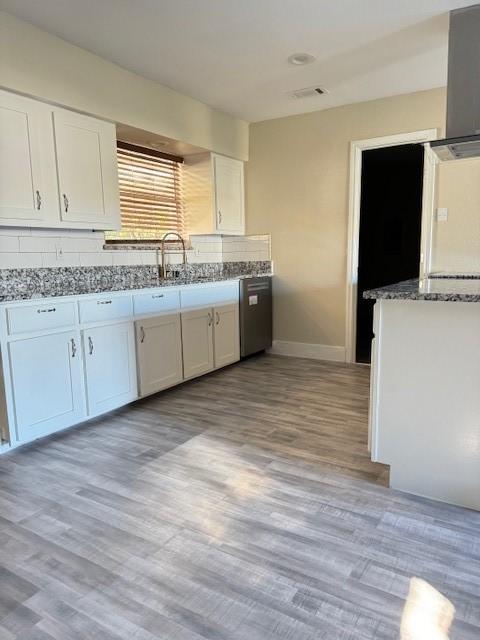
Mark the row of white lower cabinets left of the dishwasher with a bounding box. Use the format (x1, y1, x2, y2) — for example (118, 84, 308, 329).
(0, 283, 244, 445)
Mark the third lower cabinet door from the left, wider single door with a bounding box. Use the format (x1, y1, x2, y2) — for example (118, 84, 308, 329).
(135, 313, 183, 396)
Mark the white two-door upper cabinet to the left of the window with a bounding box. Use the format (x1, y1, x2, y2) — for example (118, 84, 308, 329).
(0, 91, 120, 229)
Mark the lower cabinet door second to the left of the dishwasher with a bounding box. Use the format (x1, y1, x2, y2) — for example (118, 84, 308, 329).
(182, 308, 213, 379)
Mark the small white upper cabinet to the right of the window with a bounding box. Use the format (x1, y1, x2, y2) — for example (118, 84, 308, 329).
(183, 153, 245, 235)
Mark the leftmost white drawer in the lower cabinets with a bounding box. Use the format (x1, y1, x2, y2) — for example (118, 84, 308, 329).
(7, 302, 75, 335)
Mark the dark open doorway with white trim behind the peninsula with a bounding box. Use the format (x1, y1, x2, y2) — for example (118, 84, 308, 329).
(356, 144, 424, 363)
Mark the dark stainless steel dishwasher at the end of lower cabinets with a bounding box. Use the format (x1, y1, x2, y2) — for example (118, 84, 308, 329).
(240, 276, 272, 358)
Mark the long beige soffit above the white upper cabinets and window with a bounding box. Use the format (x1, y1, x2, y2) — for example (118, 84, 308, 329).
(0, 12, 248, 160)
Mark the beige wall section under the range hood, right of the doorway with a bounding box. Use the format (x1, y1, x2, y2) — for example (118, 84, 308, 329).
(432, 158, 480, 273)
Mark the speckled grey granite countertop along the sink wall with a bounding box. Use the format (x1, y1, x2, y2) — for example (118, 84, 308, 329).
(0, 261, 271, 303)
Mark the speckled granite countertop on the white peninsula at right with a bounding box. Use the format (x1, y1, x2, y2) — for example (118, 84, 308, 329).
(363, 275, 480, 302)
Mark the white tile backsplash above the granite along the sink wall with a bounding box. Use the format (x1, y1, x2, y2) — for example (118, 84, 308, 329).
(0, 227, 270, 269)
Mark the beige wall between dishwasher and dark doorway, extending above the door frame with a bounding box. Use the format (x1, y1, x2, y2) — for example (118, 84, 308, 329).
(247, 89, 445, 346)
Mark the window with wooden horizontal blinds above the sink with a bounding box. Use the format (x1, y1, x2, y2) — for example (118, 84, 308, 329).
(105, 142, 184, 242)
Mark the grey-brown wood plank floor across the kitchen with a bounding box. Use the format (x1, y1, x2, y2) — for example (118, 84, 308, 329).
(0, 356, 480, 640)
